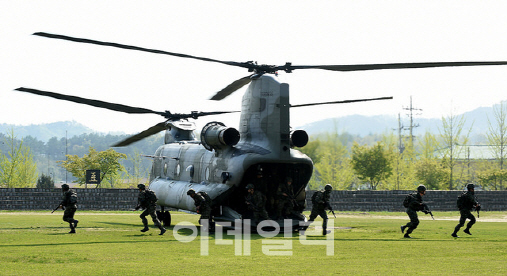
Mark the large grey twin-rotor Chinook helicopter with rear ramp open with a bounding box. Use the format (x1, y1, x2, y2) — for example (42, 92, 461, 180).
(16, 32, 507, 228)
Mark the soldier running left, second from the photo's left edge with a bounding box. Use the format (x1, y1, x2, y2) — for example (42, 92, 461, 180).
(135, 184, 166, 235)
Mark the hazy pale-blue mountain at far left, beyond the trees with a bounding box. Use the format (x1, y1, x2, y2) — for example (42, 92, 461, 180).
(0, 121, 96, 142)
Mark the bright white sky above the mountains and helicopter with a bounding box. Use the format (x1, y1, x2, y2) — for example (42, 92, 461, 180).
(0, 0, 507, 136)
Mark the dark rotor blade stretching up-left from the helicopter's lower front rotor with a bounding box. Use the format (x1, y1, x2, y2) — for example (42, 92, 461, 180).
(15, 87, 166, 116)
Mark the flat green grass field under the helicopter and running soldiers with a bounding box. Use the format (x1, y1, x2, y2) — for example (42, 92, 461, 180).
(0, 210, 507, 275)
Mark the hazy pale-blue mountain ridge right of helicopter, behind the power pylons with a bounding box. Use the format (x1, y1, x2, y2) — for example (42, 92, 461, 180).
(297, 104, 502, 142)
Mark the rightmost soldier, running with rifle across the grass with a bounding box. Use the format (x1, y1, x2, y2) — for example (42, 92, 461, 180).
(451, 183, 481, 238)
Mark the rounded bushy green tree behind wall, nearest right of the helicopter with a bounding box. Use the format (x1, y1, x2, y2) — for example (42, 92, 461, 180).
(351, 142, 393, 190)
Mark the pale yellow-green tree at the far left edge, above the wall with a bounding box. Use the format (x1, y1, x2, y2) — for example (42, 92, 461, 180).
(0, 130, 37, 188)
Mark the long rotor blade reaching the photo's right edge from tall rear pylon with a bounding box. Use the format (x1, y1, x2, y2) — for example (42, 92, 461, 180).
(288, 61, 507, 72)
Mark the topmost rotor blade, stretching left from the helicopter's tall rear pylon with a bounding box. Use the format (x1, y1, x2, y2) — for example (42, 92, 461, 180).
(33, 32, 252, 68)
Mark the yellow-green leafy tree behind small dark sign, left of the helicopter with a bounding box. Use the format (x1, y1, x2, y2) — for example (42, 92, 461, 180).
(57, 147, 127, 188)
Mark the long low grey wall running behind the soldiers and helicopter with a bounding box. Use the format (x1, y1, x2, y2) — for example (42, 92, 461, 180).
(0, 188, 507, 212)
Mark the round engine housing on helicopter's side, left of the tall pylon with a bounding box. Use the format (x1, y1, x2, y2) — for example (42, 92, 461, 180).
(201, 122, 240, 151)
